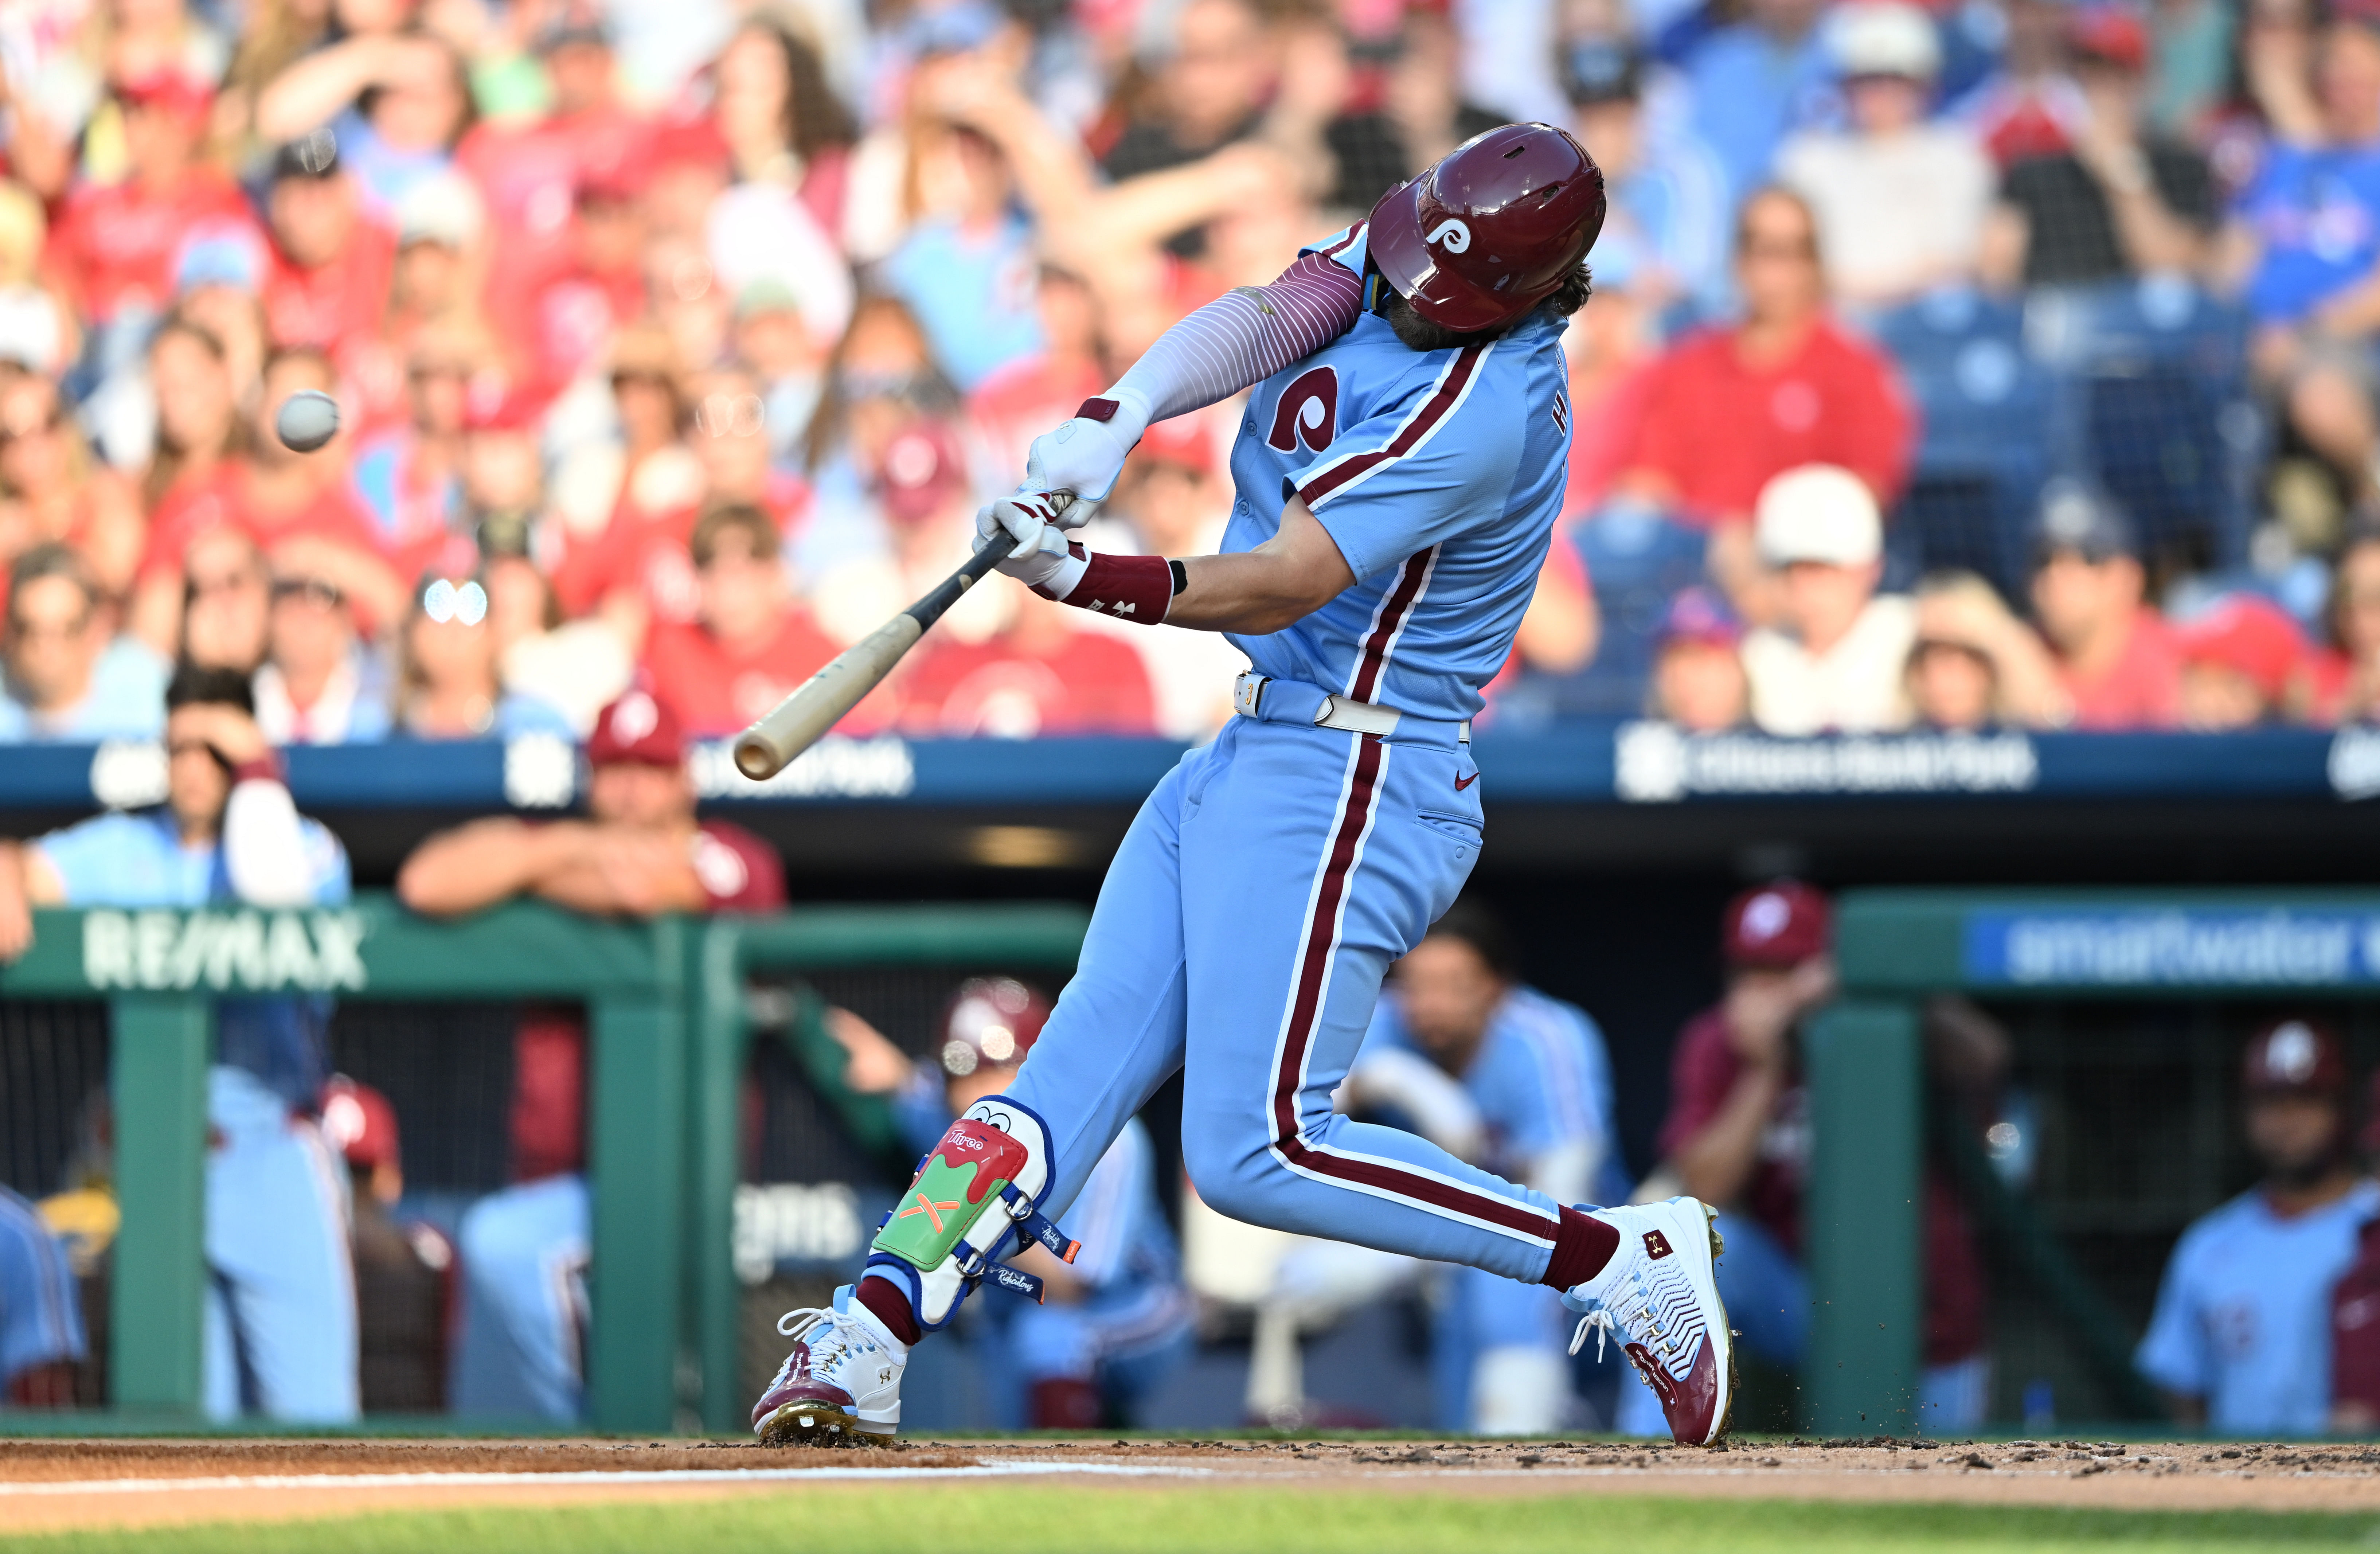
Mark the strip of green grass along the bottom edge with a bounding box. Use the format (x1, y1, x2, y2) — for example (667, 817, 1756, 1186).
(14, 1483, 2380, 1554)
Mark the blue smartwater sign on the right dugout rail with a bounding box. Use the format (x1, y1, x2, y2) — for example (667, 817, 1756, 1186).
(1961, 907, 2380, 988)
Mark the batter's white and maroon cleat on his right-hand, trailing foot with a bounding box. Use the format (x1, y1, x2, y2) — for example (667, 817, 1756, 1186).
(1561, 1197, 1735, 1447)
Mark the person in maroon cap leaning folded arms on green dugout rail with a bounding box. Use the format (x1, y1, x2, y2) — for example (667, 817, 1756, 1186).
(398, 690, 785, 1421)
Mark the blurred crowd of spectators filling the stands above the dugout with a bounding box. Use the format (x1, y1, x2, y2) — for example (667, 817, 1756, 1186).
(0, 0, 2380, 745)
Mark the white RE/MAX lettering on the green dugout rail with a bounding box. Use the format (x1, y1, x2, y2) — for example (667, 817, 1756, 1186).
(83, 911, 367, 992)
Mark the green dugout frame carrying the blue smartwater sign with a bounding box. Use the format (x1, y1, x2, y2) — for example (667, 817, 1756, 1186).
(1802, 890, 2380, 1435)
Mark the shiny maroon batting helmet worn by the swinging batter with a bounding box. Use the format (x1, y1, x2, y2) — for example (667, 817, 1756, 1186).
(1366, 124, 1604, 333)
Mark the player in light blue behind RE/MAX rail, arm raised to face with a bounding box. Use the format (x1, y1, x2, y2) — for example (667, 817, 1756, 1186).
(0, 666, 359, 1423)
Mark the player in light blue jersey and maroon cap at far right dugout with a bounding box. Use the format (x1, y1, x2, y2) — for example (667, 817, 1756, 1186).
(2135, 1019, 2380, 1437)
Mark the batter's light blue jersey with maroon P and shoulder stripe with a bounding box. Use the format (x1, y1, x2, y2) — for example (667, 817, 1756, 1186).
(1221, 226, 1571, 721)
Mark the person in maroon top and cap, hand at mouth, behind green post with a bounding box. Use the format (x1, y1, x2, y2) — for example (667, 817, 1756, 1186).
(1618, 881, 2006, 1433)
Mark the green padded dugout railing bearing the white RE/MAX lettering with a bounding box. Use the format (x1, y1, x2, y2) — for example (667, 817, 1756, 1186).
(0, 895, 1088, 1433)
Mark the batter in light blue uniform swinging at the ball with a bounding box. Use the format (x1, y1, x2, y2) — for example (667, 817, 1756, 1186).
(752, 124, 1733, 1445)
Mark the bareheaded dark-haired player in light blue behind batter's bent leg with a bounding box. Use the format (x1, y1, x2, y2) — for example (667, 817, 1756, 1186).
(1342, 902, 1628, 1435)
